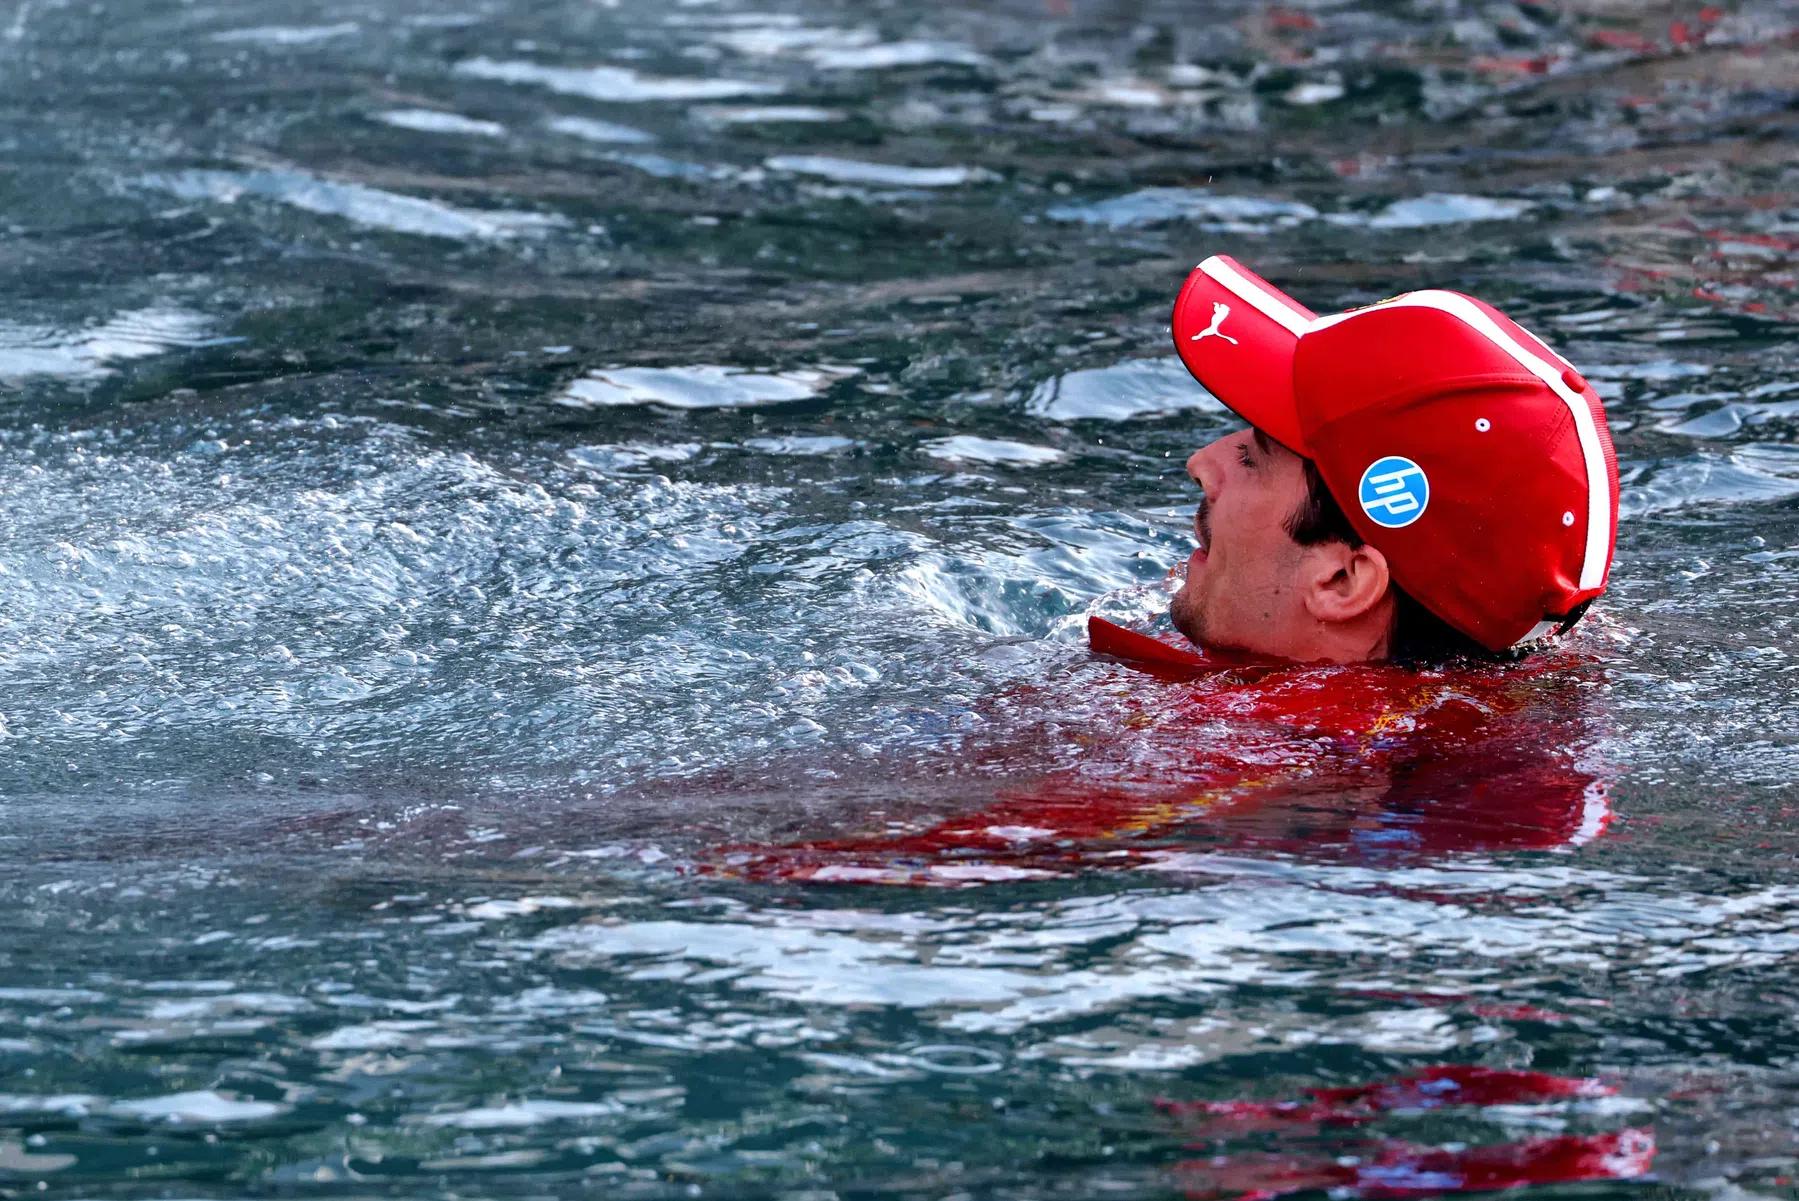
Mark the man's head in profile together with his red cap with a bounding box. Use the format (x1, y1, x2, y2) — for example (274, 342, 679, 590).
(1169, 255, 1617, 663)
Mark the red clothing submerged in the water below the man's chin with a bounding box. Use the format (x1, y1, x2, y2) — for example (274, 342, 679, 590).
(702, 618, 1610, 886)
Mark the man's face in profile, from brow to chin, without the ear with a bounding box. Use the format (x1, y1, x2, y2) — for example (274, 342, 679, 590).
(1169, 430, 1317, 658)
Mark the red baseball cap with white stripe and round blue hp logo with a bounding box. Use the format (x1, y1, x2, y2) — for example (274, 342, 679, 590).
(1175, 255, 1617, 651)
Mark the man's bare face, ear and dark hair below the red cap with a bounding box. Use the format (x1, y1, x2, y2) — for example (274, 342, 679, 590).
(1169, 430, 1484, 663)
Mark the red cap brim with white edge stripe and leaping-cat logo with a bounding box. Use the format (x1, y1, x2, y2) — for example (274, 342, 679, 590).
(1175, 255, 1317, 458)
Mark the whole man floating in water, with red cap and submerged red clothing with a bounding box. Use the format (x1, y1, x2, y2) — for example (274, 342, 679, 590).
(714, 257, 1617, 885)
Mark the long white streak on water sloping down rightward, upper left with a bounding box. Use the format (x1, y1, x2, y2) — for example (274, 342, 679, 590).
(144, 171, 568, 241)
